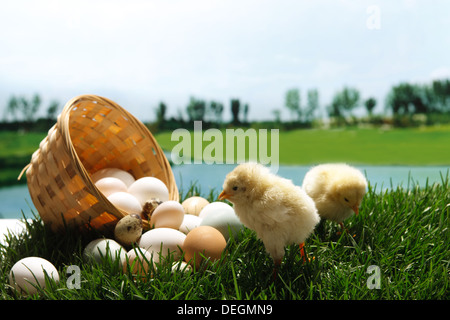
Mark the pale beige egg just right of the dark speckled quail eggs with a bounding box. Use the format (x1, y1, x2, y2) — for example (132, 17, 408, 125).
(150, 200, 185, 229)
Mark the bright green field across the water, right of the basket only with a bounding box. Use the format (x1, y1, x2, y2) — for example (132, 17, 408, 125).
(155, 126, 450, 165)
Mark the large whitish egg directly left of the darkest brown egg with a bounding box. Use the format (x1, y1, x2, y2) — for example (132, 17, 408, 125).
(139, 228, 186, 259)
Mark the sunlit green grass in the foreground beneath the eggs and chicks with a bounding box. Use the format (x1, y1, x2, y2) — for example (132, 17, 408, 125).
(0, 177, 450, 300)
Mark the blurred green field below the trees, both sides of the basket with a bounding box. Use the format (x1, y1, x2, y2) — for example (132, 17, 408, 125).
(0, 126, 450, 185)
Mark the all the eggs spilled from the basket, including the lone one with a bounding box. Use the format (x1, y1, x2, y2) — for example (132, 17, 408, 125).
(9, 168, 243, 294)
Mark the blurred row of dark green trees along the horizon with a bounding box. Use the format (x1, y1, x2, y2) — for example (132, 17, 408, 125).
(1, 79, 450, 131)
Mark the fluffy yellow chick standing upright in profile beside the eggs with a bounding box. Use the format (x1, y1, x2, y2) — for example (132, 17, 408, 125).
(219, 163, 320, 271)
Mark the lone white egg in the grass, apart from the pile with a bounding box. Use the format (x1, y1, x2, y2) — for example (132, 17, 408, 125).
(9, 257, 59, 295)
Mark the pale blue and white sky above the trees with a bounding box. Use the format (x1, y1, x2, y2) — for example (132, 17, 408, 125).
(0, 0, 450, 121)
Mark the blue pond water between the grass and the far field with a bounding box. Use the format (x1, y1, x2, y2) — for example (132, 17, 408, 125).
(0, 164, 450, 219)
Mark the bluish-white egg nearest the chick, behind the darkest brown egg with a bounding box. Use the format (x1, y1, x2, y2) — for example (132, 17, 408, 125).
(200, 209, 244, 241)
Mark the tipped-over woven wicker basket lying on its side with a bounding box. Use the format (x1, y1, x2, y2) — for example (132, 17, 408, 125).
(19, 95, 179, 234)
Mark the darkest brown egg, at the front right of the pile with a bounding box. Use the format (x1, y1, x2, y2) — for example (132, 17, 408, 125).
(183, 226, 227, 268)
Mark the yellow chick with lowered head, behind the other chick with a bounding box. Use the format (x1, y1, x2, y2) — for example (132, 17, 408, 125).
(302, 164, 367, 229)
